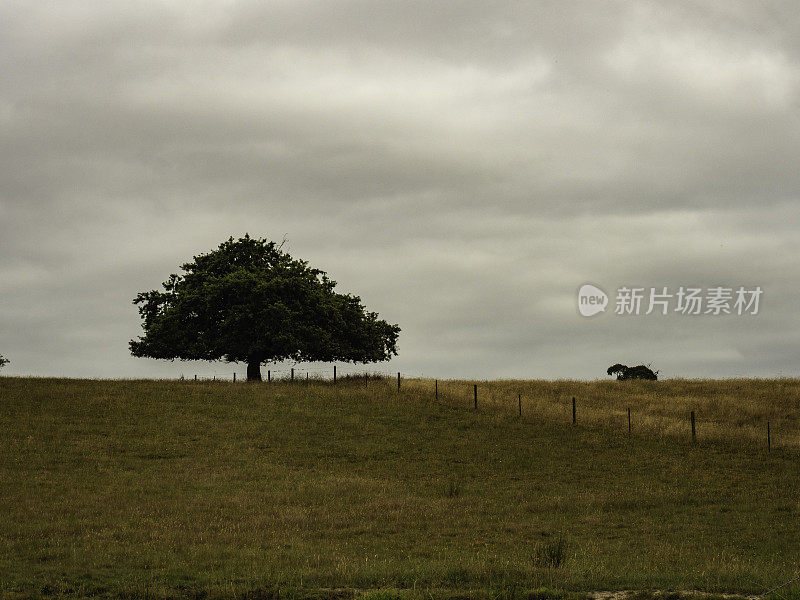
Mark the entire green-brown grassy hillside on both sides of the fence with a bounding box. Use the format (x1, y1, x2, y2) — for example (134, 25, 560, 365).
(0, 377, 800, 600)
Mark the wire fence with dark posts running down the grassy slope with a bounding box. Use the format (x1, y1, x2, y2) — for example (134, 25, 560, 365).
(181, 365, 800, 452)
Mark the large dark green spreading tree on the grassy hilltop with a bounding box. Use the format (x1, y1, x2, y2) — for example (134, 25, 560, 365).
(130, 235, 400, 381)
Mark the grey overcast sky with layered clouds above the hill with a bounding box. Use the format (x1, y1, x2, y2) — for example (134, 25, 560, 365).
(0, 0, 800, 379)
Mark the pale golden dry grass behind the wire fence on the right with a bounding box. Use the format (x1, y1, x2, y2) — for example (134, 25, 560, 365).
(416, 379, 800, 448)
